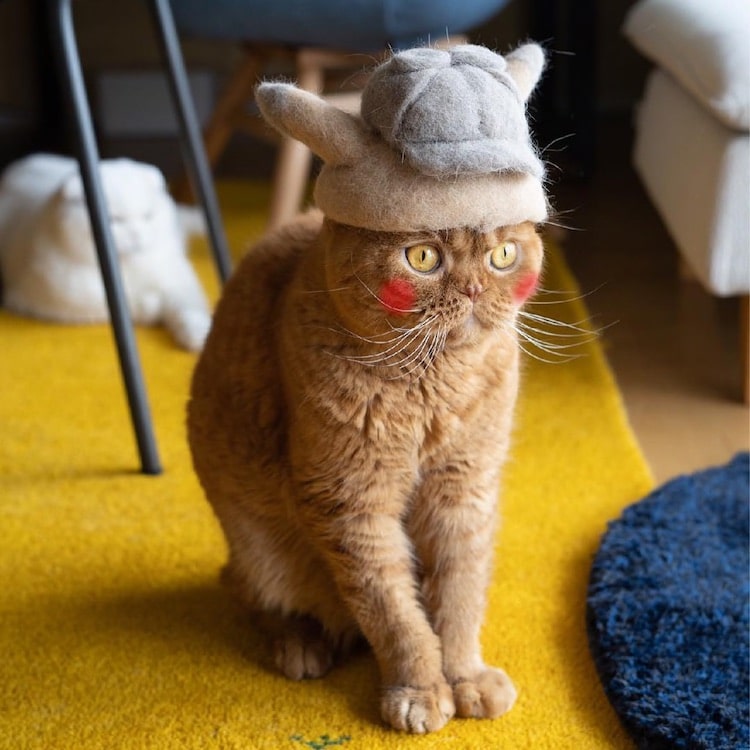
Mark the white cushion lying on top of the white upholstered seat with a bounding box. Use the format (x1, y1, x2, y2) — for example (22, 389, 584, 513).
(623, 0, 750, 131)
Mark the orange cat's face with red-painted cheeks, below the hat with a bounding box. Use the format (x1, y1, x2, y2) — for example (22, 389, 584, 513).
(325, 222, 543, 356)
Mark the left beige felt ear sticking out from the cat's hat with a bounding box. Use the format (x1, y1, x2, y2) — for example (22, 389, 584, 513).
(255, 83, 367, 164)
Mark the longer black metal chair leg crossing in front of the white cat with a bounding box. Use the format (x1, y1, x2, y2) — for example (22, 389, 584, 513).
(50, 0, 161, 474)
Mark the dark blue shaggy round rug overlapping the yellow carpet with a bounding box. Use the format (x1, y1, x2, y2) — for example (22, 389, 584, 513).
(588, 453, 750, 750)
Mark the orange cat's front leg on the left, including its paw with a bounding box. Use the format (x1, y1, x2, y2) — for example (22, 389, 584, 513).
(296, 488, 455, 734)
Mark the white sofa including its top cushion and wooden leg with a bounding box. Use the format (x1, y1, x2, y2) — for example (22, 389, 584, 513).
(623, 0, 750, 401)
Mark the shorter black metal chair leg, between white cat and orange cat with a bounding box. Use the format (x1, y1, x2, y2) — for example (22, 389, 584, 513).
(149, 0, 232, 282)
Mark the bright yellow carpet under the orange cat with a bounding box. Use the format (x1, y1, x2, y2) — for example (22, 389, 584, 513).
(0, 187, 652, 750)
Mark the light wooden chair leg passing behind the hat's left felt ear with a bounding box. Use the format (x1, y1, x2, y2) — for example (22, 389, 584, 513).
(268, 50, 324, 230)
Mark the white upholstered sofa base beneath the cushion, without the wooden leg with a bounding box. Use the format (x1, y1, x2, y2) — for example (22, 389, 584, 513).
(633, 68, 750, 297)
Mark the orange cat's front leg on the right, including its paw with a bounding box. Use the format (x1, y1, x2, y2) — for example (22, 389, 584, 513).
(410, 458, 516, 718)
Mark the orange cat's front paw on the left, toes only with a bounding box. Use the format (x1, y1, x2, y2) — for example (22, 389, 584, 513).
(380, 683, 456, 734)
